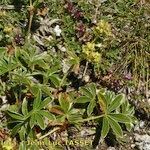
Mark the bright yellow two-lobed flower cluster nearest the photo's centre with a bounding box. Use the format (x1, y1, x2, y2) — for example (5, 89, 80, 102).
(82, 42, 101, 63)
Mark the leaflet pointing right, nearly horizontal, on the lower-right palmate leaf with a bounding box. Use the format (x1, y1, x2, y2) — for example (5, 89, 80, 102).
(109, 113, 131, 123)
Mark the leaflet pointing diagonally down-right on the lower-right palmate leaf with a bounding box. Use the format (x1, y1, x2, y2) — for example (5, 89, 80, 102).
(108, 116, 123, 137)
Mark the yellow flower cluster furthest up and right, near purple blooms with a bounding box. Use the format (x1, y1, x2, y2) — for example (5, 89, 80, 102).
(95, 20, 112, 36)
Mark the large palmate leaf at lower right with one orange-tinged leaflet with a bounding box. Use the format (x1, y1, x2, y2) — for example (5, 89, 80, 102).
(98, 92, 135, 138)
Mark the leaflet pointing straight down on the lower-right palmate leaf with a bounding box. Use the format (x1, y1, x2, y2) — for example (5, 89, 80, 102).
(101, 117, 110, 138)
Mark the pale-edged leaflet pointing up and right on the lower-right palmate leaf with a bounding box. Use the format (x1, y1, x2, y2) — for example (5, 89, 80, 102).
(108, 94, 124, 112)
